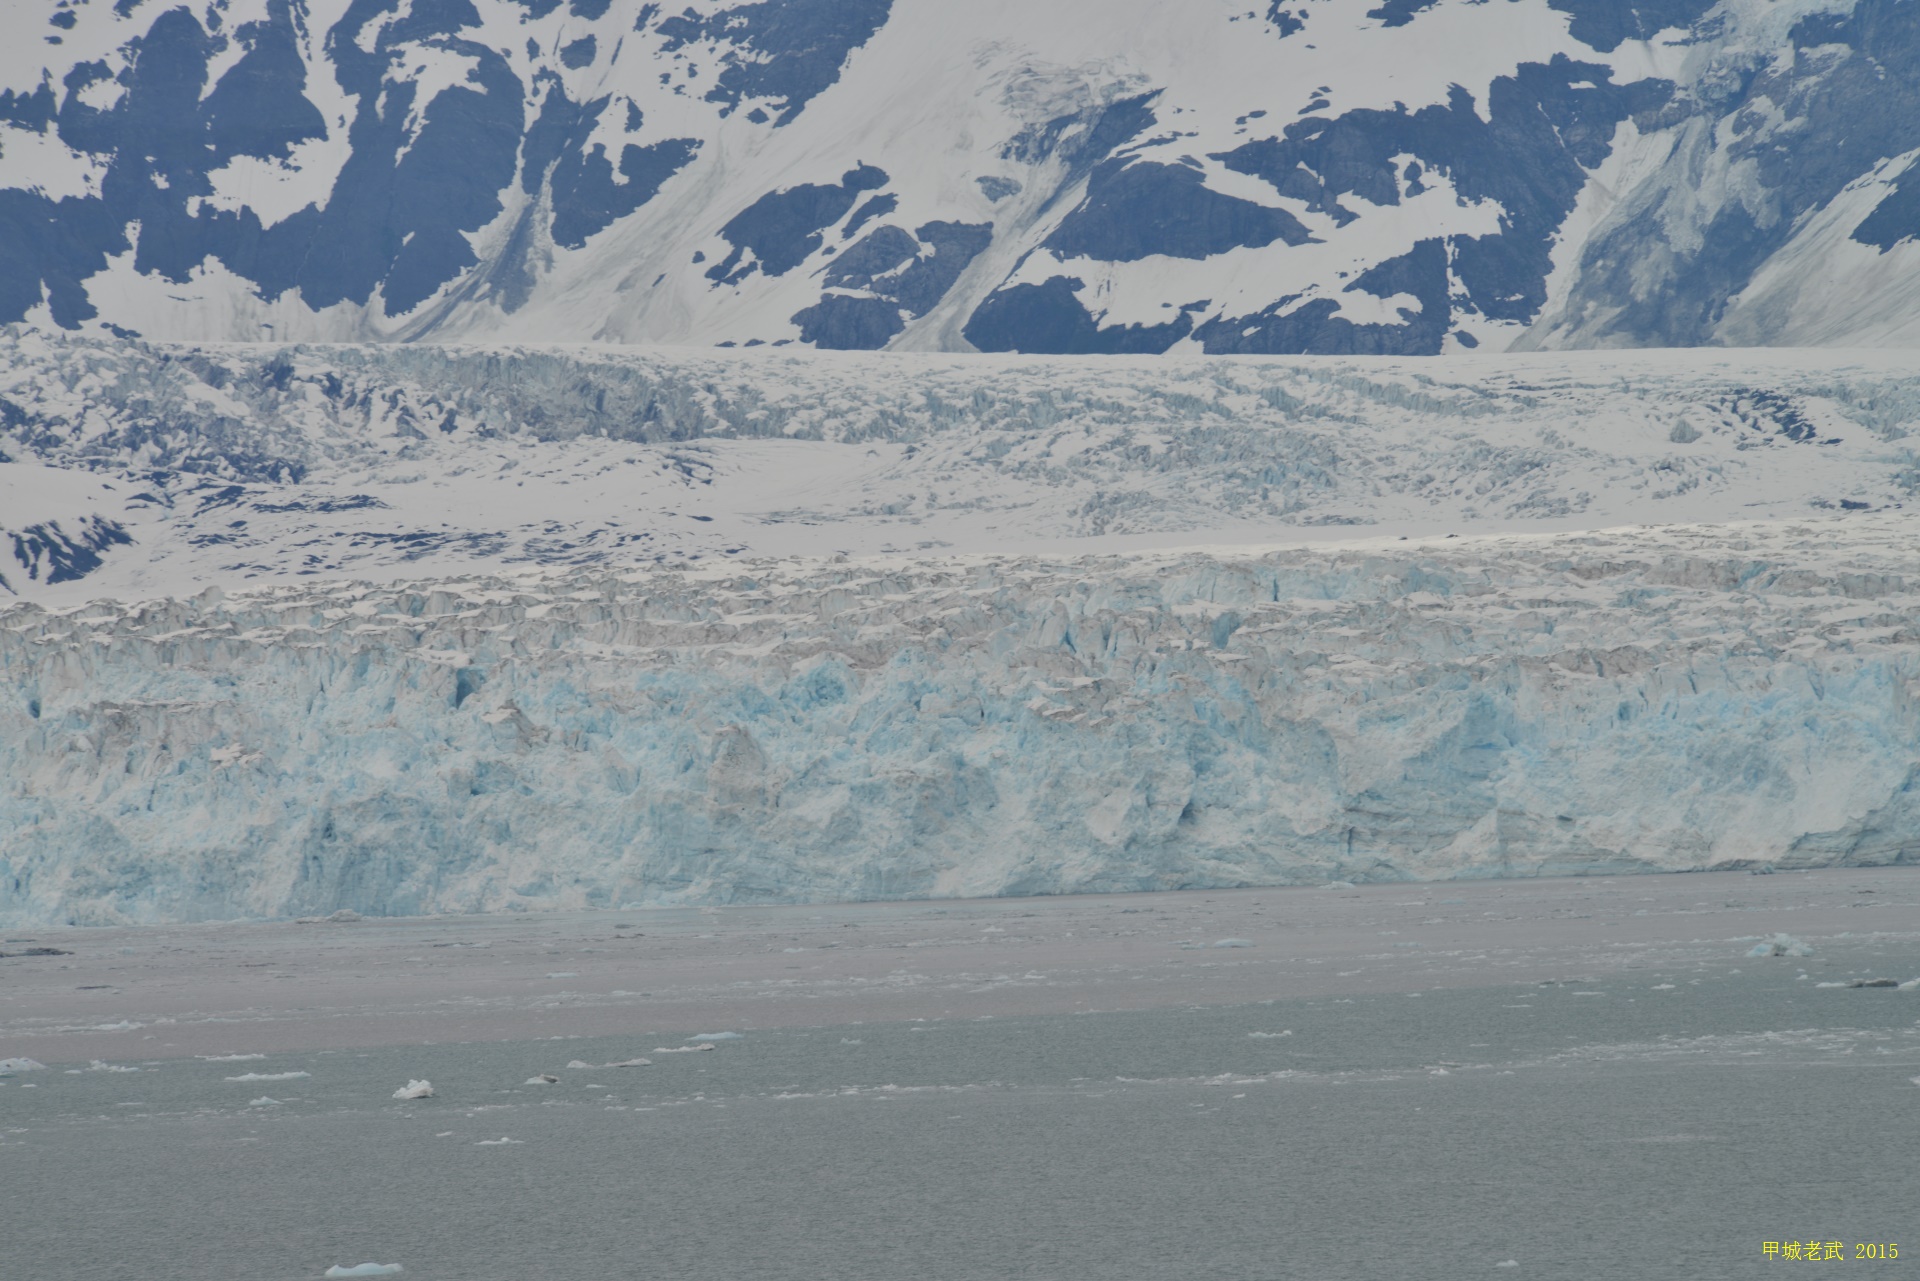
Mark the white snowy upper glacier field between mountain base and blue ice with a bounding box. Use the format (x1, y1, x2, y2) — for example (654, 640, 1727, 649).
(0, 332, 1920, 603)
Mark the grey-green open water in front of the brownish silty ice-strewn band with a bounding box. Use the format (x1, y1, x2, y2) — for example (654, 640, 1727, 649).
(0, 971, 1920, 1281)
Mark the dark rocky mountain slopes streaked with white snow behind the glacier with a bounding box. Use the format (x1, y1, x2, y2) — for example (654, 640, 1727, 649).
(11, 0, 1920, 355)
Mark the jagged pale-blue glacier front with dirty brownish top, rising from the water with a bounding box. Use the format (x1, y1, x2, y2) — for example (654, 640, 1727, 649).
(0, 515, 1920, 924)
